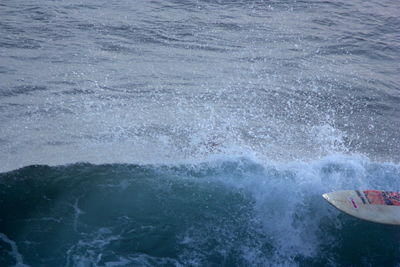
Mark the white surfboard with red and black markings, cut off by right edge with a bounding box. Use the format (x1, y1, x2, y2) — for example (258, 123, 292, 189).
(322, 190, 400, 225)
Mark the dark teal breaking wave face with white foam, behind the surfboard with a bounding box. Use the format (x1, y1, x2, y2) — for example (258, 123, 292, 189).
(0, 156, 400, 266)
